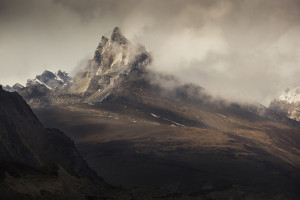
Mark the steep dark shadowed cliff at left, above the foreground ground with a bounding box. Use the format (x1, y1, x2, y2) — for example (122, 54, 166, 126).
(0, 87, 100, 180)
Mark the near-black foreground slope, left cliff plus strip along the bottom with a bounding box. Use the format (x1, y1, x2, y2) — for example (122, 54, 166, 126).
(0, 88, 282, 200)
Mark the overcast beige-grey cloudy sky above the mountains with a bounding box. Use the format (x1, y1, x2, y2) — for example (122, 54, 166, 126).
(0, 0, 300, 105)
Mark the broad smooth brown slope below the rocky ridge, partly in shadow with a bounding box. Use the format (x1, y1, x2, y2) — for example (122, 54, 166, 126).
(34, 102, 300, 196)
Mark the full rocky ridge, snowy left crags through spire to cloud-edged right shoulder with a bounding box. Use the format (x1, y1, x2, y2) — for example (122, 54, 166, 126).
(3, 27, 300, 127)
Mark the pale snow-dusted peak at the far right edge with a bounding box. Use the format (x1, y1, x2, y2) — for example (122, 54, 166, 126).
(269, 87, 300, 122)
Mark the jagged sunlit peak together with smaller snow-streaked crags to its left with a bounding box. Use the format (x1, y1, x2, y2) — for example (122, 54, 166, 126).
(4, 27, 151, 105)
